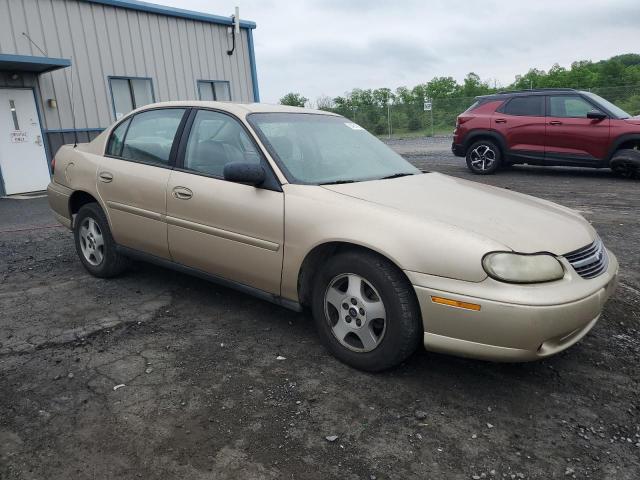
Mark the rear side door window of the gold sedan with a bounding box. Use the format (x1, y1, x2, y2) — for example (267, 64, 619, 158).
(119, 108, 184, 165)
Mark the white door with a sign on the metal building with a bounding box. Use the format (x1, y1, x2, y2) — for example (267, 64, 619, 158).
(0, 88, 49, 195)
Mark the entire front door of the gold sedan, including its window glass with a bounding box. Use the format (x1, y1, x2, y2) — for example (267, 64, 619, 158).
(167, 110, 284, 295)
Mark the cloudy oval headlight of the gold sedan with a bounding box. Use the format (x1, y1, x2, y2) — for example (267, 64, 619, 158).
(482, 252, 564, 283)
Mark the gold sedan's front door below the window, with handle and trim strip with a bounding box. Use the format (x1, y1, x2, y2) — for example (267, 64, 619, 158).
(167, 171, 284, 295)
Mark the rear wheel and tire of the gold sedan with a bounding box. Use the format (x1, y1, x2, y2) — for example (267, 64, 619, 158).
(73, 203, 128, 278)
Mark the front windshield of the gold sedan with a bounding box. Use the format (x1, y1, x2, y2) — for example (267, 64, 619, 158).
(249, 113, 421, 185)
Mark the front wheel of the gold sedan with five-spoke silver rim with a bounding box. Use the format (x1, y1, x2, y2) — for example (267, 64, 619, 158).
(312, 251, 423, 372)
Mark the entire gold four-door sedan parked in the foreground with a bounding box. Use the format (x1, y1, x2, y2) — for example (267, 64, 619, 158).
(48, 102, 618, 371)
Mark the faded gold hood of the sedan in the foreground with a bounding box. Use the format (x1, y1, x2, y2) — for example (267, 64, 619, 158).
(324, 173, 596, 255)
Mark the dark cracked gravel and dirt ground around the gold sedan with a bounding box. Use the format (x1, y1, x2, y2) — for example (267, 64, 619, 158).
(0, 139, 640, 480)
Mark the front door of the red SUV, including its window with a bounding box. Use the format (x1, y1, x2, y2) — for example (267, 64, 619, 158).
(545, 95, 610, 161)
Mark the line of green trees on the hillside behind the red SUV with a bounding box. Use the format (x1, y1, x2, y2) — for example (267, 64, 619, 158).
(280, 53, 640, 135)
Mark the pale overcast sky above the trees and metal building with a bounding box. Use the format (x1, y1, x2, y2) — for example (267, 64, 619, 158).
(164, 0, 640, 103)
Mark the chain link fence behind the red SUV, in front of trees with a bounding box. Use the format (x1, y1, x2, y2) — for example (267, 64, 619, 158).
(334, 85, 640, 138)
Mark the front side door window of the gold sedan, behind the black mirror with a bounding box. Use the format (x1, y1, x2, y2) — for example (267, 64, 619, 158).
(184, 110, 261, 177)
